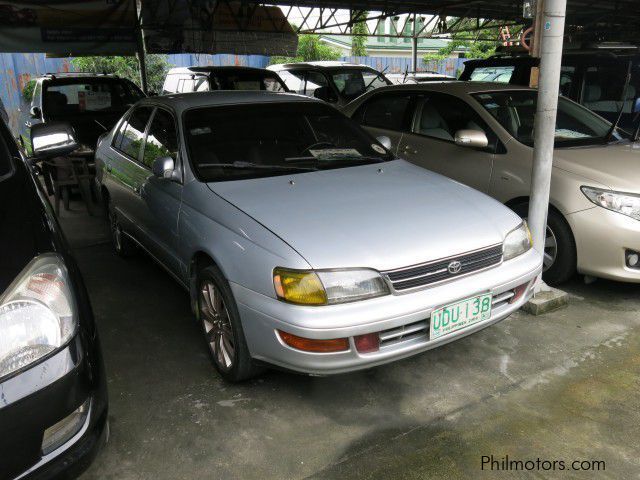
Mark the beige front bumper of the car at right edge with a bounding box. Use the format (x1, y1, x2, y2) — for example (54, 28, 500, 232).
(566, 207, 640, 283)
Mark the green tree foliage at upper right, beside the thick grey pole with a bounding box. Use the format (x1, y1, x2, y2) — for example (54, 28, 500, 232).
(424, 19, 508, 62)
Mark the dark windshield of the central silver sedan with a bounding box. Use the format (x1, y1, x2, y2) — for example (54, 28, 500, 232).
(184, 102, 392, 182)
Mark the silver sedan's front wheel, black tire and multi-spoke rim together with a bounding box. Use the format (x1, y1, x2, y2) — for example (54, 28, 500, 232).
(196, 265, 262, 383)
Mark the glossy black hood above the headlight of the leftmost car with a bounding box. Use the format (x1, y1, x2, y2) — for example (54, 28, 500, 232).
(0, 159, 57, 295)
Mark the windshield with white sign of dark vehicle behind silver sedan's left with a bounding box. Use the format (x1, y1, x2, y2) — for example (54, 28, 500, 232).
(43, 79, 144, 118)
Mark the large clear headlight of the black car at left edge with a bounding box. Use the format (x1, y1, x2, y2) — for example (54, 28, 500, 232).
(0, 254, 76, 378)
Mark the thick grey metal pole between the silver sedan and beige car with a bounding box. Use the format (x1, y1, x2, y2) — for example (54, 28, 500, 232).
(529, 0, 567, 274)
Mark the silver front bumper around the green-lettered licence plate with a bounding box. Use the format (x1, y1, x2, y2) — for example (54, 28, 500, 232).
(231, 249, 541, 375)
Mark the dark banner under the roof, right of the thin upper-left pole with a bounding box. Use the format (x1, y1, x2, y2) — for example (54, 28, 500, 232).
(142, 0, 298, 56)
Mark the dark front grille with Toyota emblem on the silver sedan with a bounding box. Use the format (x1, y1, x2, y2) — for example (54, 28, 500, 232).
(384, 245, 502, 291)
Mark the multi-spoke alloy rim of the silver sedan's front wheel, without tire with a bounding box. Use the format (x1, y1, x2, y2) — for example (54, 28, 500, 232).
(199, 281, 235, 370)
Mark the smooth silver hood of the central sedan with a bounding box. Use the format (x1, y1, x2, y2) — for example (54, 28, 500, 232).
(209, 160, 521, 270)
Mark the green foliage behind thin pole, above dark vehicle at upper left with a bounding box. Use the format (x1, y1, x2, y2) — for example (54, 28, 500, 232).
(71, 55, 169, 92)
